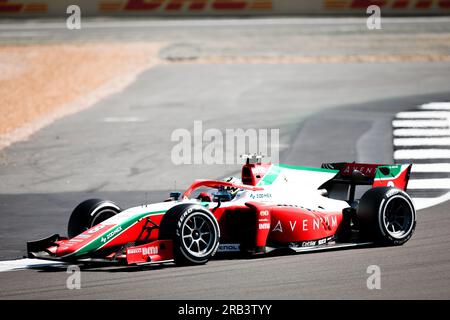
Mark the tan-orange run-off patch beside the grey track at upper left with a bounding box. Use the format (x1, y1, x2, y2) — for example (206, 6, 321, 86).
(0, 42, 161, 148)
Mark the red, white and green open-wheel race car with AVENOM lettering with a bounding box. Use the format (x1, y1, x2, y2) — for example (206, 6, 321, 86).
(27, 156, 416, 265)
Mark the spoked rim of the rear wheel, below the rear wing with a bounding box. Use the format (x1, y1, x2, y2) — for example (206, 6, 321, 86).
(383, 196, 414, 239)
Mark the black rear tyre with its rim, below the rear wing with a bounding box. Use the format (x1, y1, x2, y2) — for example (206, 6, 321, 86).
(357, 187, 416, 245)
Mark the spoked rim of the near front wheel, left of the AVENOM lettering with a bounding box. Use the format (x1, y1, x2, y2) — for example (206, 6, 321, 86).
(181, 214, 215, 258)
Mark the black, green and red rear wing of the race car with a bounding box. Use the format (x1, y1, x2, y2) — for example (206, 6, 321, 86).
(322, 162, 412, 198)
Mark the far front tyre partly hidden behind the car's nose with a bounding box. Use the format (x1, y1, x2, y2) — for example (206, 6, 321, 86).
(67, 199, 122, 238)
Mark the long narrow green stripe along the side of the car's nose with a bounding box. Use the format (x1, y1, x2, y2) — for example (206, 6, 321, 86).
(68, 210, 166, 257)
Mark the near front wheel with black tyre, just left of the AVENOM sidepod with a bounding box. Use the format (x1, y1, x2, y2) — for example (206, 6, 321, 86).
(159, 204, 220, 265)
